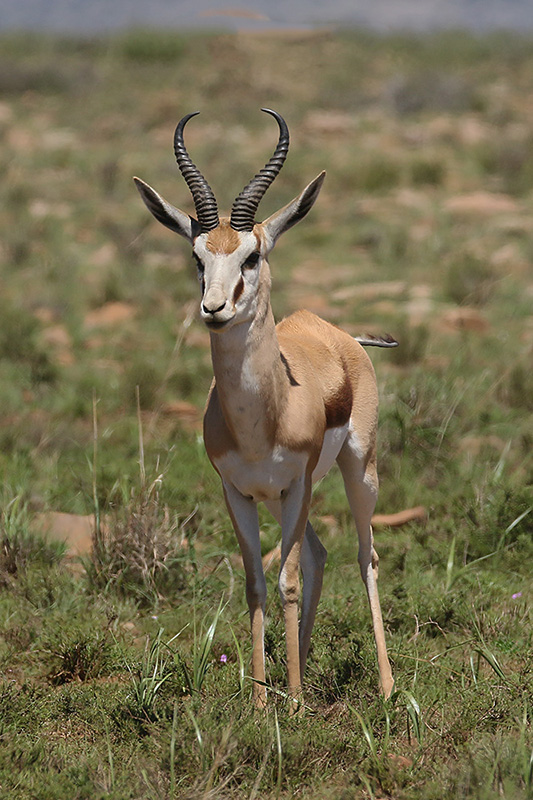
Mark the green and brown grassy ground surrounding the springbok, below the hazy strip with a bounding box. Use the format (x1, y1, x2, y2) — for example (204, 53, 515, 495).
(0, 26, 533, 800)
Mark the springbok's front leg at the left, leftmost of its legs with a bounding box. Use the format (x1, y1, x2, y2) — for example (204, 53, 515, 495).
(223, 482, 267, 708)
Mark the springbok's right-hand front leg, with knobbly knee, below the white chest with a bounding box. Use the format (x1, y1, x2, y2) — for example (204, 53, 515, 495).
(279, 474, 311, 701)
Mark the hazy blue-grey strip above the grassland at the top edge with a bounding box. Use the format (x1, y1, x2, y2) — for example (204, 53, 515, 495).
(0, 0, 533, 34)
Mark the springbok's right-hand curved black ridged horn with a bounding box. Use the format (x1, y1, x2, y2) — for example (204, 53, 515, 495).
(230, 108, 289, 231)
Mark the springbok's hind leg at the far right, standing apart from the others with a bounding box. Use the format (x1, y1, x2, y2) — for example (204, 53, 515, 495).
(337, 434, 394, 697)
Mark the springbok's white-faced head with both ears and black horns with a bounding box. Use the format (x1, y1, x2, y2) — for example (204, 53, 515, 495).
(134, 108, 326, 331)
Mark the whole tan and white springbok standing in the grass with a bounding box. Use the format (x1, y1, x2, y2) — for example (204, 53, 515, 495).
(134, 108, 396, 708)
